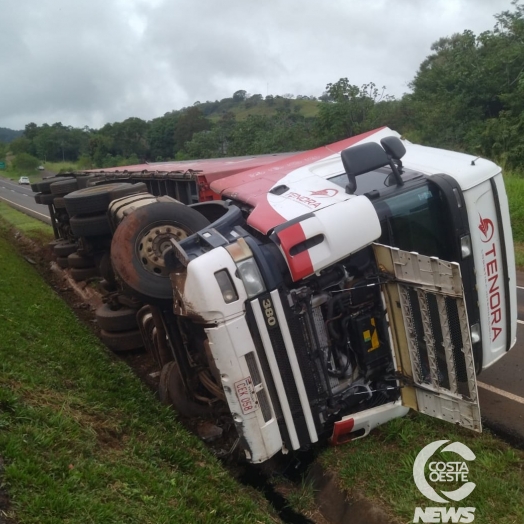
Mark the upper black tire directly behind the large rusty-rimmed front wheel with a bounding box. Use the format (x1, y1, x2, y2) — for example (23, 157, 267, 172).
(64, 182, 147, 216)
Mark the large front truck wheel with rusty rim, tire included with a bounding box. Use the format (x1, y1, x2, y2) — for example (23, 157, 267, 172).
(111, 202, 209, 304)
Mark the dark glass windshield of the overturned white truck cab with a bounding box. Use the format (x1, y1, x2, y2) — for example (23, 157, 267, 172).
(373, 182, 456, 260)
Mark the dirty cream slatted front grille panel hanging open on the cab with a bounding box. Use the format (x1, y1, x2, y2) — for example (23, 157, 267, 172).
(373, 244, 481, 432)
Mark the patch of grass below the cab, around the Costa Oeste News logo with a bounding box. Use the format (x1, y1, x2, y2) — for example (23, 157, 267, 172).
(320, 414, 524, 524)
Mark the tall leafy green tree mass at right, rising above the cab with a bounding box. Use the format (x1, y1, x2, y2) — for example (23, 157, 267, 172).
(410, 2, 524, 165)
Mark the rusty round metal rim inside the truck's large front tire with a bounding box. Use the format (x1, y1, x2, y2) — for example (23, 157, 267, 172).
(138, 224, 188, 277)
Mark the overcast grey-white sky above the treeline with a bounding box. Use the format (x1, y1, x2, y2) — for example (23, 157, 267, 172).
(0, 0, 512, 129)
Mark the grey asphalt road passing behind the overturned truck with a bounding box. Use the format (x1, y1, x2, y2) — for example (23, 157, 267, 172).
(0, 178, 524, 445)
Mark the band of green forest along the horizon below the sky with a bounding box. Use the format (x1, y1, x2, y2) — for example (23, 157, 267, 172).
(0, 0, 524, 169)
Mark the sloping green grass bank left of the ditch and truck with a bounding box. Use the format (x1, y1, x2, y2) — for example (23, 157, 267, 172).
(0, 215, 274, 524)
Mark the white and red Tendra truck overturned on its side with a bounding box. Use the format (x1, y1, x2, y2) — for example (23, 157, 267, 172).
(35, 128, 516, 463)
